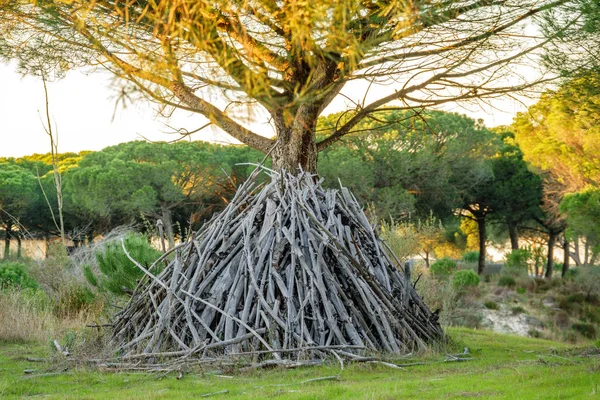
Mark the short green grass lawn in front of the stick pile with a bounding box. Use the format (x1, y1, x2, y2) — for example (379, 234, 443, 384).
(0, 329, 600, 399)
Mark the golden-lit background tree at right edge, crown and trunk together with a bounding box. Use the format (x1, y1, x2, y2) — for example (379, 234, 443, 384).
(512, 70, 600, 274)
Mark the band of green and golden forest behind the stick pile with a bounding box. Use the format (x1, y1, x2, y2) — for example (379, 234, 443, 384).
(0, 65, 600, 276)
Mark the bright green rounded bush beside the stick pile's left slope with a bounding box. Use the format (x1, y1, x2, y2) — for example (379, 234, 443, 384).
(83, 233, 162, 294)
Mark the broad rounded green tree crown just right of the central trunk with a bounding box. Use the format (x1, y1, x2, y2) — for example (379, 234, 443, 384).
(319, 111, 495, 220)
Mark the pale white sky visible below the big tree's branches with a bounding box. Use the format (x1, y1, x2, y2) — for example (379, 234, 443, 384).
(0, 64, 525, 157)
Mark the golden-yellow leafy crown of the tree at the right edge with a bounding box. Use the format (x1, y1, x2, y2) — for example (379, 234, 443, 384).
(512, 72, 600, 191)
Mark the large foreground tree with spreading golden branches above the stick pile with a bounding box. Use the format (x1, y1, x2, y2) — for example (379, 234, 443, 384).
(0, 0, 584, 171)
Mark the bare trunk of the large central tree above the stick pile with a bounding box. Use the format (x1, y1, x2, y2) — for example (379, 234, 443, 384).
(271, 106, 319, 174)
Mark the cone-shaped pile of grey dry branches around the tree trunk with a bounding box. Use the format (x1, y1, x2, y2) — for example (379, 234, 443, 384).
(112, 170, 443, 362)
